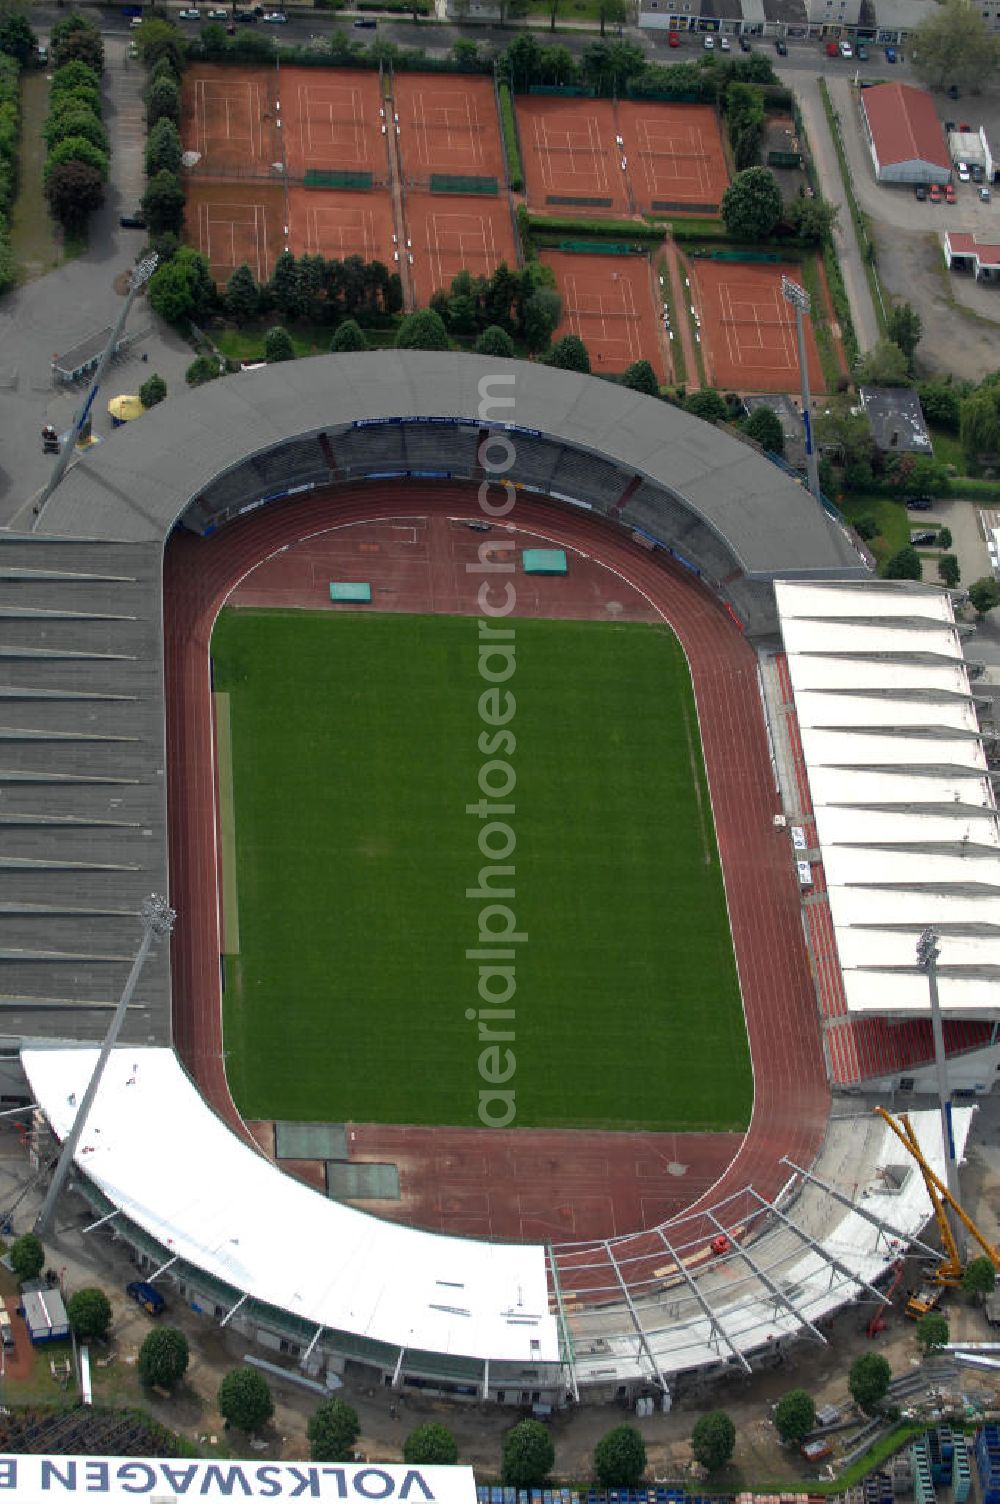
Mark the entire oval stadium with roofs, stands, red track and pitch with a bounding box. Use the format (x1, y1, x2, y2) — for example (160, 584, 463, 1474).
(0, 350, 1000, 1405)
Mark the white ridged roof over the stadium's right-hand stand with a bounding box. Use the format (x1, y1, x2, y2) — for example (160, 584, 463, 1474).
(774, 581, 1000, 1018)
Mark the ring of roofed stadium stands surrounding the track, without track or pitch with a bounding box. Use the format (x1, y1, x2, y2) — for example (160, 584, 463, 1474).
(0, 350, 997, 1405)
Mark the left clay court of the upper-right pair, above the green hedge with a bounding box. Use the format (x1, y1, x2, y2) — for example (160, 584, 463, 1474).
(516, 95, 630, 214)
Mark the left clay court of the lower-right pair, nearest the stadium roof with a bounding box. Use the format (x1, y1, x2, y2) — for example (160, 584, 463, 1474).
(540, 251, 666, 381)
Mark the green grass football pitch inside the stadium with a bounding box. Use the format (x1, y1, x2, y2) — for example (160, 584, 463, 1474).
(212, 609, 752, 1130)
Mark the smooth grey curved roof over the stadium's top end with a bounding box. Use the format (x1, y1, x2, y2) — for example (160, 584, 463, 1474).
(41, 350, 859, 578)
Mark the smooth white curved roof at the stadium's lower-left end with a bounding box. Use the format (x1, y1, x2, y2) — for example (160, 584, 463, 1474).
(21, 1045, 559, 1363)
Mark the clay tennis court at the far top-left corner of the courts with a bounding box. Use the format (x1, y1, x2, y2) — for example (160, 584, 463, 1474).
(180, 63, 281, 177)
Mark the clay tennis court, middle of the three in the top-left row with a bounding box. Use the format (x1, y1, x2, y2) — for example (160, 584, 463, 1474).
(281, 68, 388, 180)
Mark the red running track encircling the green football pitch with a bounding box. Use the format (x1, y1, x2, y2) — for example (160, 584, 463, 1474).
(164, 483, 829, 1295)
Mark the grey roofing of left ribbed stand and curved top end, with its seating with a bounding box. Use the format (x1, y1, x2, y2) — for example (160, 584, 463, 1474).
(0, 350, 865, 1044)
